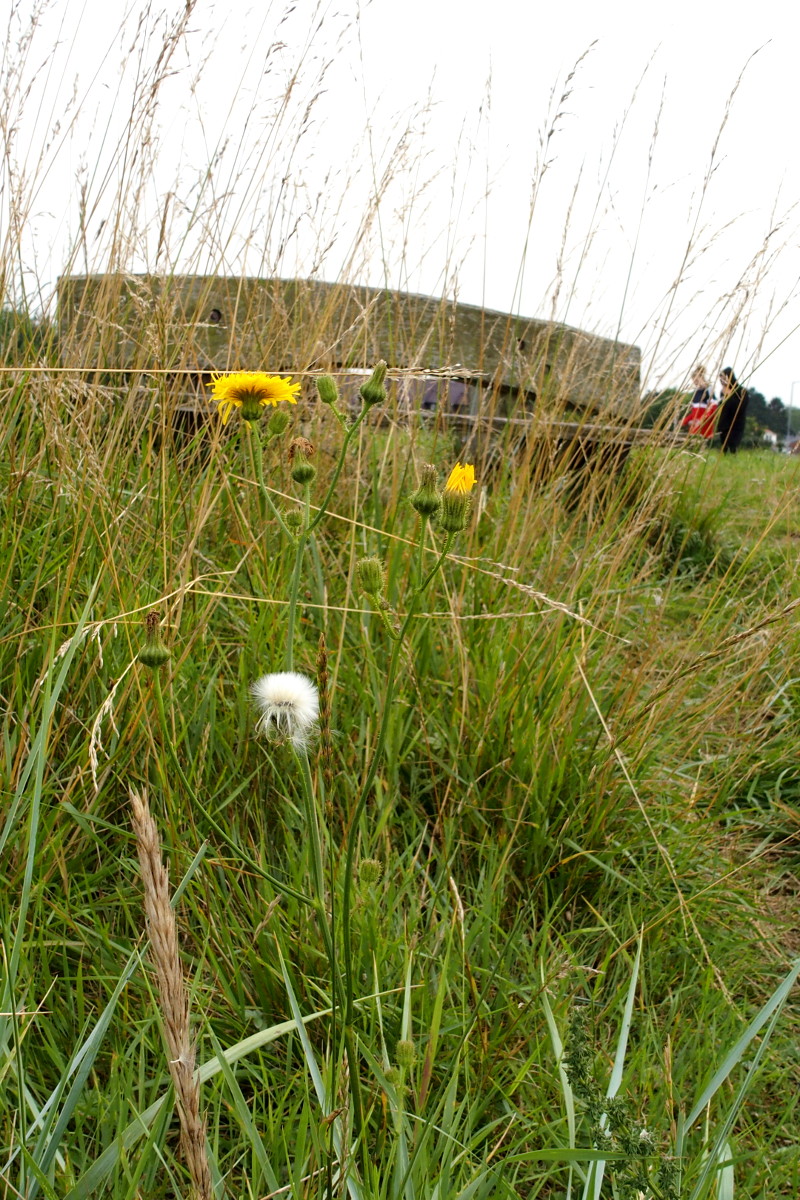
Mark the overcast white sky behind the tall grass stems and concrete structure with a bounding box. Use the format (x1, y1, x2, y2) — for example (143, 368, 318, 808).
(6, 0, 800, 403)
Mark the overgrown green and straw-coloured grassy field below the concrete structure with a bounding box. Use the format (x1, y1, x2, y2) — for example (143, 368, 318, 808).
(0, 357, 800, 1200)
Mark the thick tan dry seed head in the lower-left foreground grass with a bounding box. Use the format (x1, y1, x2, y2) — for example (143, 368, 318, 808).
(130, 788, 212, 1200)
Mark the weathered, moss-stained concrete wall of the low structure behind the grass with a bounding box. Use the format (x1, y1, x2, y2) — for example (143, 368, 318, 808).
(59, 275, 640, 420)
